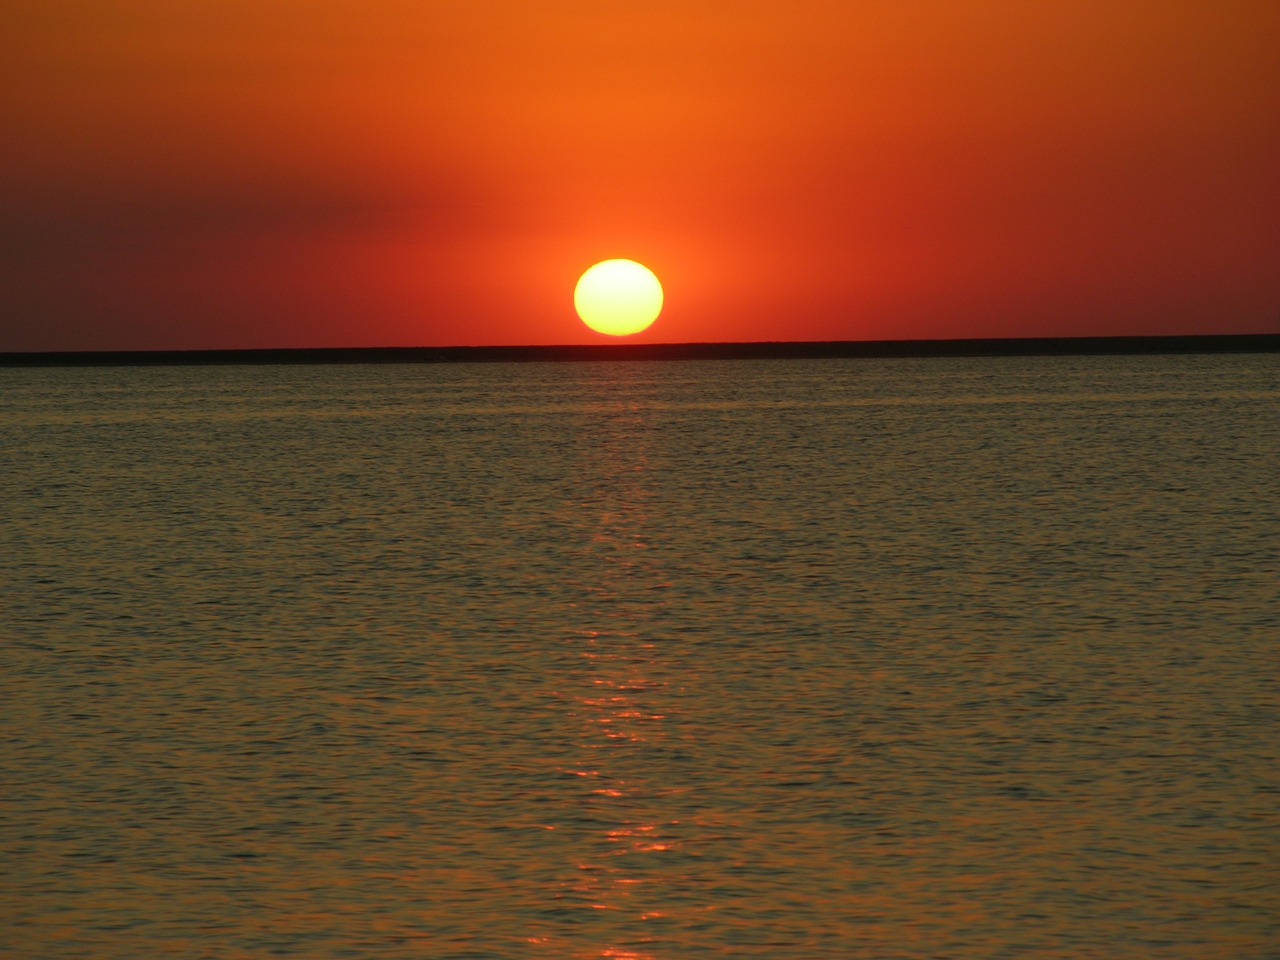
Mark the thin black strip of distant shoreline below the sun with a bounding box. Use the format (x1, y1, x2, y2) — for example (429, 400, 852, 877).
(0, 333, 1280, 366)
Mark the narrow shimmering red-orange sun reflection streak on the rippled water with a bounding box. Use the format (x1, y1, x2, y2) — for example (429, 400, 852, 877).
(566, 384, 678, 960)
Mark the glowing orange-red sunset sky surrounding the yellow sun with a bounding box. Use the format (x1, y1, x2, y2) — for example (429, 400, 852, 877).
(0, 0, 1280, 351)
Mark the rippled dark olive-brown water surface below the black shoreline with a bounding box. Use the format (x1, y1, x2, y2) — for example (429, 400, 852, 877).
(0, 355, 1280, 960)
